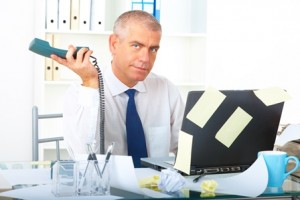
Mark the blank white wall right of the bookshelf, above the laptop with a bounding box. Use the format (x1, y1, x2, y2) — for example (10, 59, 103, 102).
(207, 0, 300, 123)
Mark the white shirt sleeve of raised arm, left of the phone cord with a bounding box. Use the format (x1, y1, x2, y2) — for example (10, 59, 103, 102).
(63, 84, 99, 158)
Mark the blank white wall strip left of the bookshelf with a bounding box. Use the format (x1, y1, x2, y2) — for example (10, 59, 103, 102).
(0, 0, 35, 161)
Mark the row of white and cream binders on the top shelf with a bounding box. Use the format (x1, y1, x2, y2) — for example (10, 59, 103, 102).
(45, 0, 106, 31)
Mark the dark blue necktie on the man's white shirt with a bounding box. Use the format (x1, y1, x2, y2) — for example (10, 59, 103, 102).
(125, 89, 147, 168)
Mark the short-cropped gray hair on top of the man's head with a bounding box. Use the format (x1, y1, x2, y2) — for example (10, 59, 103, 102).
(113, 10, 162, 38)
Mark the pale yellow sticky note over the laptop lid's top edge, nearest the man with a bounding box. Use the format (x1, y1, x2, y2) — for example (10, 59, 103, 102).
(186, 87, 226, 128)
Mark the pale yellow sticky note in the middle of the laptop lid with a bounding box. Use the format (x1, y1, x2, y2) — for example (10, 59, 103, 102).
(215, 107, 252, 148)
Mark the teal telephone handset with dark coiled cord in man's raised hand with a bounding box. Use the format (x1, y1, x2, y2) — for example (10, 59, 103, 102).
(29, 38, 105, 154)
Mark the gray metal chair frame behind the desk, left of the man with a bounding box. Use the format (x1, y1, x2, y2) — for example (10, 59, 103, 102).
(32, 106, 64, 161)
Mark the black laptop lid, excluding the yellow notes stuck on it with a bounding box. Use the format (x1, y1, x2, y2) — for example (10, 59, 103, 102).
(182, 90, 283, 174)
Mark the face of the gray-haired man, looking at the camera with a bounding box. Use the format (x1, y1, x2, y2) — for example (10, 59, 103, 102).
(110, 23, 161, 87)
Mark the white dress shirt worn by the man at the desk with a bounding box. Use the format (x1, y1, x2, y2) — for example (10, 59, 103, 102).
(63, 68, 184, 157)
